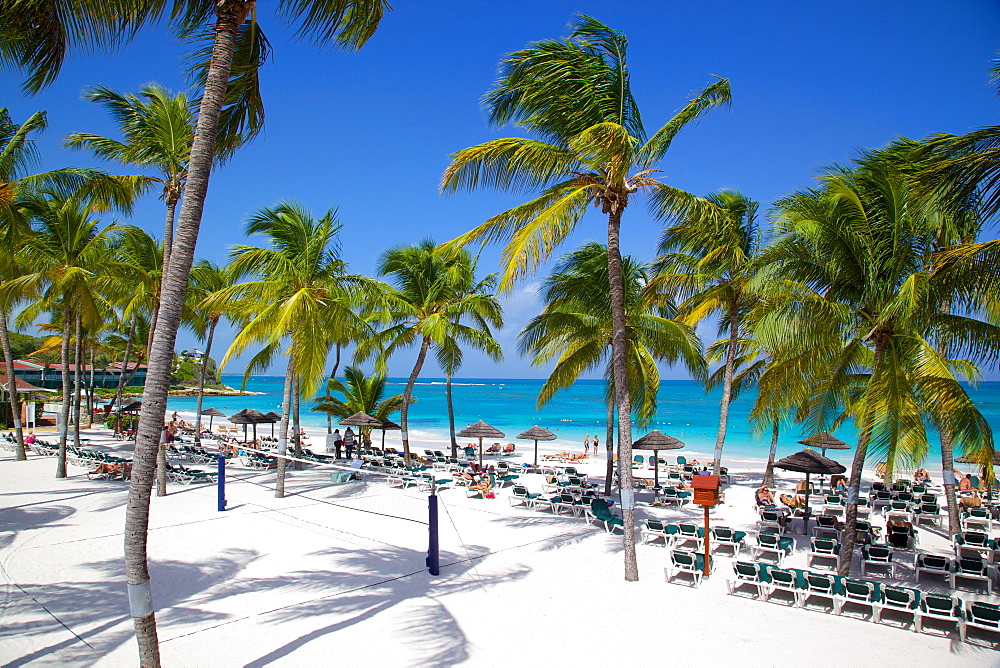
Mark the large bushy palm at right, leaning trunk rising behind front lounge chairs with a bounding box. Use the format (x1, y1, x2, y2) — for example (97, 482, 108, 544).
(755, 154, 1000, 575)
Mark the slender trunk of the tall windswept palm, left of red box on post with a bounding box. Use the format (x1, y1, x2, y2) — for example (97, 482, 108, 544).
(608, 207, 639, 582)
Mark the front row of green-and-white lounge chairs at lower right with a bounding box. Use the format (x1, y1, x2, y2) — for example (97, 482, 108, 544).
(728, 559, 1000, 646)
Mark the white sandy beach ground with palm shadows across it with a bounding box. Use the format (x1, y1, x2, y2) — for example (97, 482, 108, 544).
(0, 426, 1000, 666)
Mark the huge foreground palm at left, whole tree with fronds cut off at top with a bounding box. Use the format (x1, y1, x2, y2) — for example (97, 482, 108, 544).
(0, 0, 388, 666)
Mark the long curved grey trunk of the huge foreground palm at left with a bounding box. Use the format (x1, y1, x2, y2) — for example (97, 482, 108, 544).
(125, 0, 253, 668)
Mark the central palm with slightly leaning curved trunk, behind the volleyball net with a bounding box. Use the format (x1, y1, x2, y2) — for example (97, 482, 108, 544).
(355, 240, 503, 463)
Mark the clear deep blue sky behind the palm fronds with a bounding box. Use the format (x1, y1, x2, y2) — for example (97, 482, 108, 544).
(0, 0, 1000, 378)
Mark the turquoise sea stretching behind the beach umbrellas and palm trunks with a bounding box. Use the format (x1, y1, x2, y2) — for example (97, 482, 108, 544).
(167, 376, 1000, 463)
